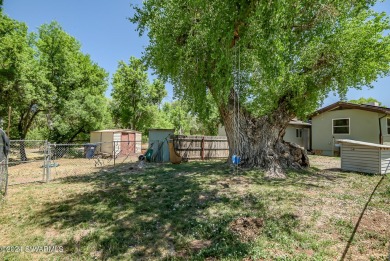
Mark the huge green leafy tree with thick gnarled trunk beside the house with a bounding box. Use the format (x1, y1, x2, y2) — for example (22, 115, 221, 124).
(131, 0, 390, 177)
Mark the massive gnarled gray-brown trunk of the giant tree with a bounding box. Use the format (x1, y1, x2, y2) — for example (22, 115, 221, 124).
(220, 91, 309, 178)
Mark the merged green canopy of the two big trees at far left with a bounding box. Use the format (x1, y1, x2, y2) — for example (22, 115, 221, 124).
(0, 17, 109, 142)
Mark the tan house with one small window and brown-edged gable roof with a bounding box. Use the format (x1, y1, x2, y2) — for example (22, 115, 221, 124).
(310, 102, 390, 156)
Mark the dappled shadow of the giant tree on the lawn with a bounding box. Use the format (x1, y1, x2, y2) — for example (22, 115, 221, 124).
(35, 162, 328, 260)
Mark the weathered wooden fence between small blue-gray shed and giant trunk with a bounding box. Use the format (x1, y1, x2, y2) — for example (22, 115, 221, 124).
(173, 135, 229, 160)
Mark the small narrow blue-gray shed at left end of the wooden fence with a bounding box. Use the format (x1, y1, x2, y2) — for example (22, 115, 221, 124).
(149, 129, 175, 162)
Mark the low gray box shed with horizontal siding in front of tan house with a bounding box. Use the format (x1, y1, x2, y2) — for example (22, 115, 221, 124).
(337, 139, 390, 174)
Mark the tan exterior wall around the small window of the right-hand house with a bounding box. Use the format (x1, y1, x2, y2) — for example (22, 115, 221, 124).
(312, 109, 380, 156)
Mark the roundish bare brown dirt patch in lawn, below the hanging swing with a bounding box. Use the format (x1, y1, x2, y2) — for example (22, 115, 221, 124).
(229, 217, 264, 242)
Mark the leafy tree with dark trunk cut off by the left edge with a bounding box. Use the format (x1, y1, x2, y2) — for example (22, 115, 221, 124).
(0, 12, 53, 160)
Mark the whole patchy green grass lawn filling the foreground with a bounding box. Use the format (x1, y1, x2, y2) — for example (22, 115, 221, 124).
(0, 158, 390, 260)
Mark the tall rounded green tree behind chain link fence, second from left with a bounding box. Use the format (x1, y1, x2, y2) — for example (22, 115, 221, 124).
(36, 22, 109, 142)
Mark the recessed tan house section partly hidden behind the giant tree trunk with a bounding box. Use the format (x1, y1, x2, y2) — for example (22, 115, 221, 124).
(218, 119, 311, 150)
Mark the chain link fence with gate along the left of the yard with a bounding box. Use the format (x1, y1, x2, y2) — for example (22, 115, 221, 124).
(4, 140, 142, 185)
